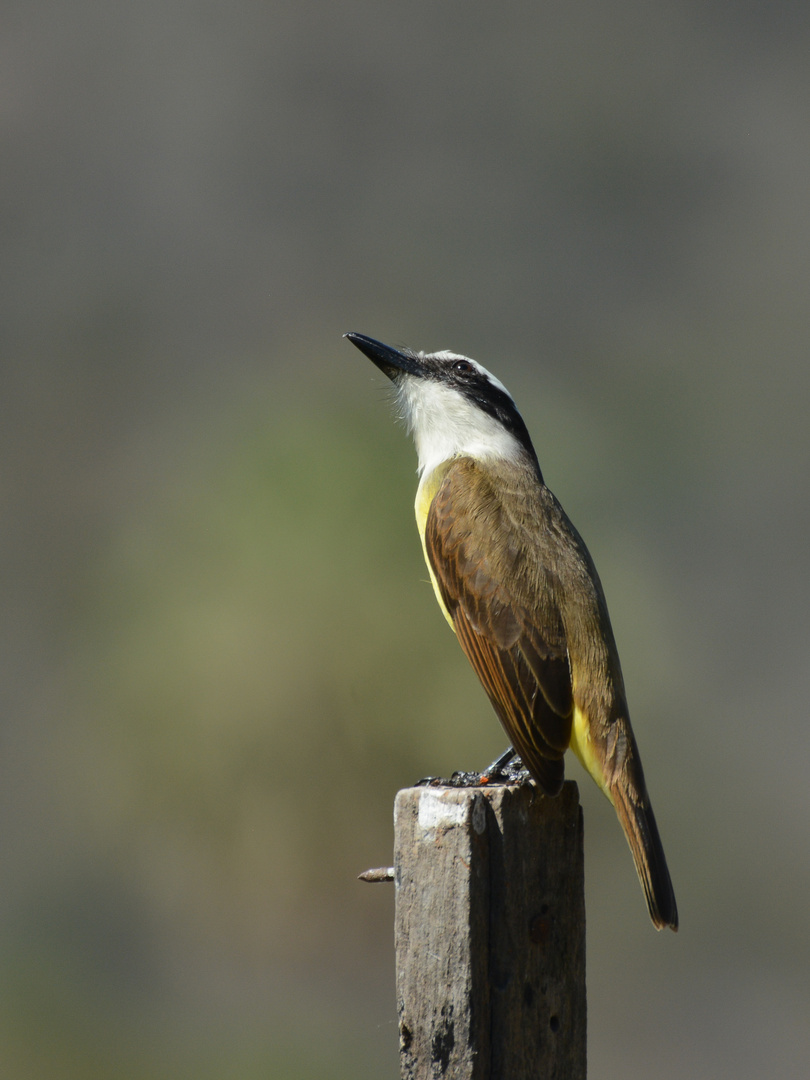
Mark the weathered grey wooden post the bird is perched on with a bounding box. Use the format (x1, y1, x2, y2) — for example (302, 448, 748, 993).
(394, 781, 585, 1080)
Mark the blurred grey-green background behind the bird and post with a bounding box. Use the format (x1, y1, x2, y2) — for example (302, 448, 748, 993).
(0, 0, 810, 1080)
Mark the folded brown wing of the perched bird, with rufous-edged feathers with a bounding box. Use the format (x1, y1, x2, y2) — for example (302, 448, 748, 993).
(424, 459, 573, 795)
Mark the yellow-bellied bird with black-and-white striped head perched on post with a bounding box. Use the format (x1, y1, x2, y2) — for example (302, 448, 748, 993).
(346, 334, 678, 930)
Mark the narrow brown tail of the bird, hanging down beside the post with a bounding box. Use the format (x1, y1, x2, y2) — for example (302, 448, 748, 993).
(610, 778, 678, 930)
